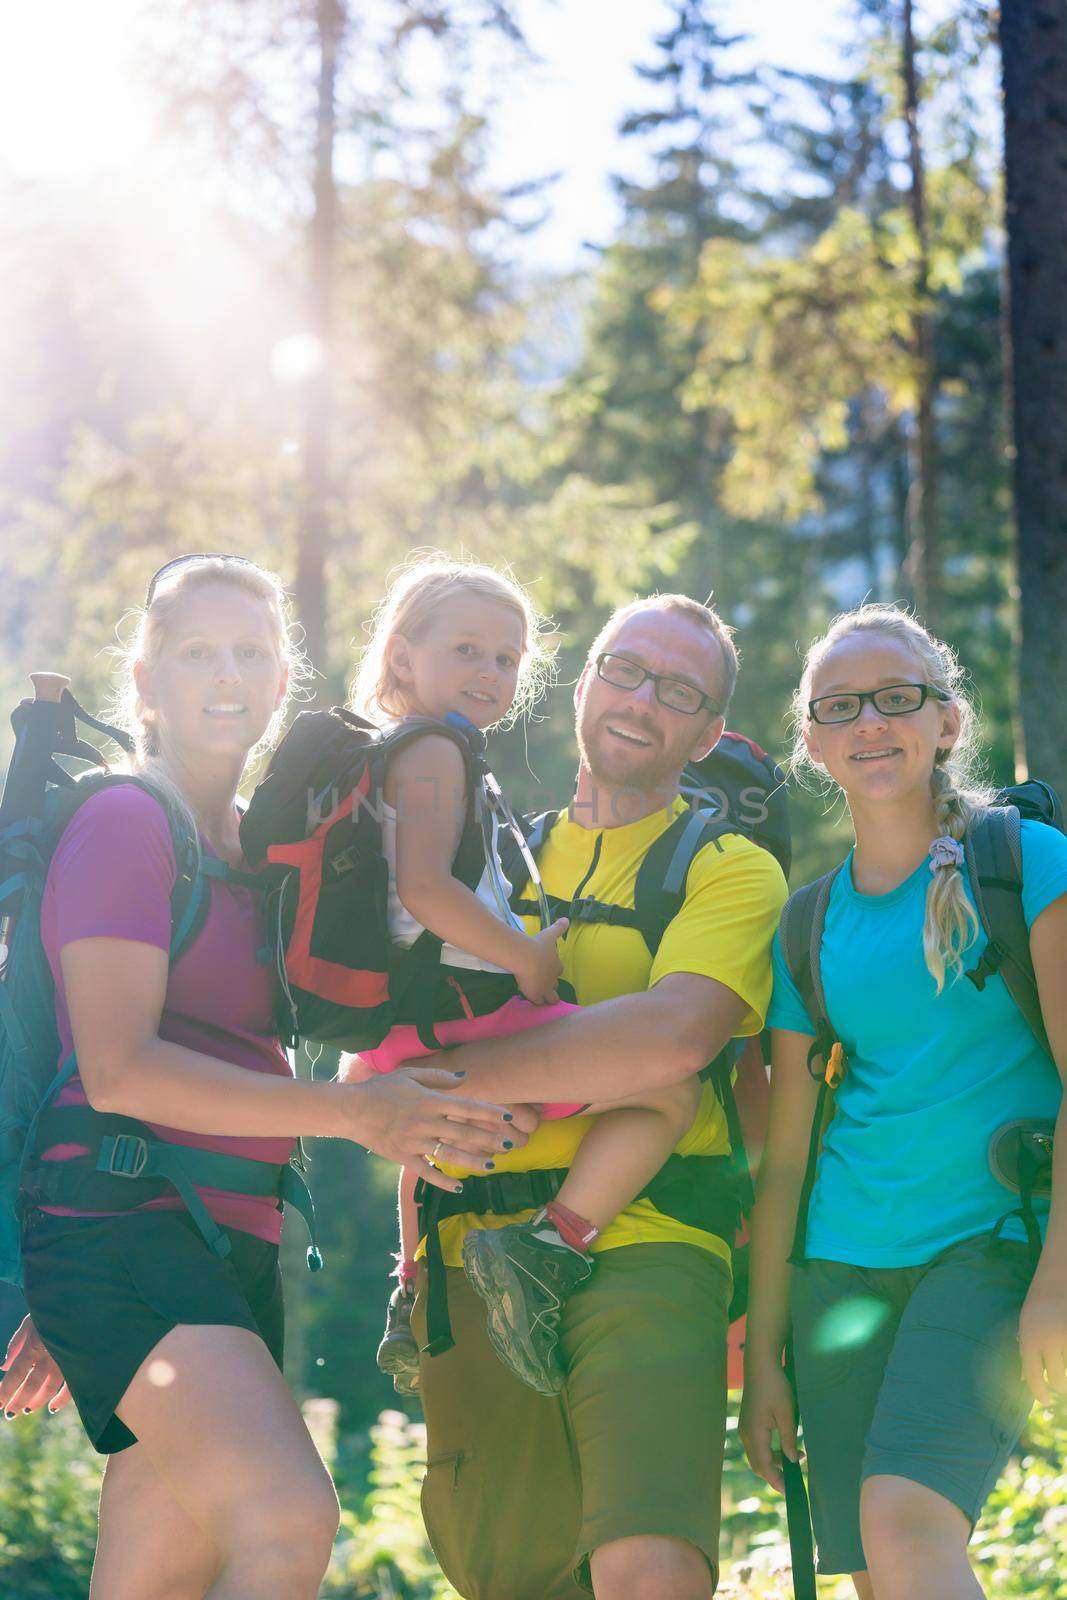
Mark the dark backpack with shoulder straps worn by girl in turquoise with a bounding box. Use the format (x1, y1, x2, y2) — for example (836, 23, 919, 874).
(781, 779, 1064, 1264)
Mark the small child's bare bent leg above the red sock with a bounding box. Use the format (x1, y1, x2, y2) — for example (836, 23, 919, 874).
(557, 1078, 701, 1229)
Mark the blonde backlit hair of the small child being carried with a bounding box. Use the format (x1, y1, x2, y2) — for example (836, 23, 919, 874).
(350, 550, 553, 726)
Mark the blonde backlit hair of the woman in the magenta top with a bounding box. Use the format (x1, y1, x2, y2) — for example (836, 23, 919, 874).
(112, 555, 312, 811)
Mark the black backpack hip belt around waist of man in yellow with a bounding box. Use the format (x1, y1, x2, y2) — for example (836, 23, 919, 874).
(416, 1155, 741, 1355)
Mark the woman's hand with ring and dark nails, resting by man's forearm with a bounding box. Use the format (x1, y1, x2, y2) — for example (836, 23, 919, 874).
(338, 1066, 526, 1194)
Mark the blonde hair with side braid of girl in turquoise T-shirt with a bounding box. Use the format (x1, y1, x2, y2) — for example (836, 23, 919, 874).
(792, 605, 992, 994)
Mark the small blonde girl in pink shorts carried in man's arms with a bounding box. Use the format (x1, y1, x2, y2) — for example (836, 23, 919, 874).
(346, 557, 697, 1394)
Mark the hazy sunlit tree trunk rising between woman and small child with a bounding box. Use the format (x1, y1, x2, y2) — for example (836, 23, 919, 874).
(296, 0, 346, 688)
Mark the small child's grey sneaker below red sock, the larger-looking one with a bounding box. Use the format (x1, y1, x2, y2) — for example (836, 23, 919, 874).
(464, 1218, 593, 1395)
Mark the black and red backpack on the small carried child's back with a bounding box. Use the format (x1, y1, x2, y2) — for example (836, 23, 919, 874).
(240, 707, 547, 1051)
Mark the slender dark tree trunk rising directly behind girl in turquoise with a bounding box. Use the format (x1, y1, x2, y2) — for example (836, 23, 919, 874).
(904, 0, 941, 627)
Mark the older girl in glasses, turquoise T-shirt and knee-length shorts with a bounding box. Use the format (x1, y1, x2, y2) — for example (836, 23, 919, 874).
(741, 606, 1067, 1600)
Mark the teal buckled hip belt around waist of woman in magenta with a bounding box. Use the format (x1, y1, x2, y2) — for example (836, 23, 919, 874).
(19, 1106, 322, 1272)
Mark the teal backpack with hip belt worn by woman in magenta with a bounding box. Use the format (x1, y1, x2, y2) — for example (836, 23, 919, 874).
(0, 674, 322, 1285)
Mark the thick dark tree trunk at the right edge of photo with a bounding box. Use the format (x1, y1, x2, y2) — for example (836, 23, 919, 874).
(1000, 0, 1067, 794)
